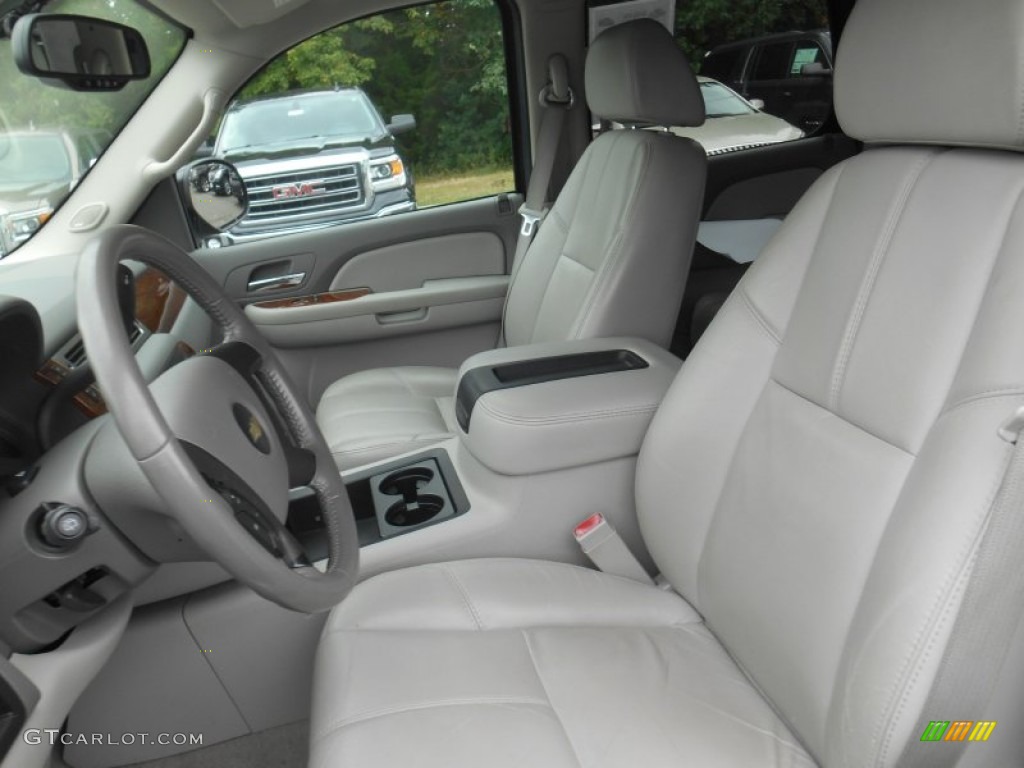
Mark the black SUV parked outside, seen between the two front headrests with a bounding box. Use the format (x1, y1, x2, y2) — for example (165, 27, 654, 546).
(700, 30, 833, 134)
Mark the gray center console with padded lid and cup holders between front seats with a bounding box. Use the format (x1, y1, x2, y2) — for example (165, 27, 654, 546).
(288, 339, 680, 561)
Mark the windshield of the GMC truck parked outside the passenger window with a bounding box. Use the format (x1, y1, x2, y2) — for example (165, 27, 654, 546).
(217, 90, 384, 155)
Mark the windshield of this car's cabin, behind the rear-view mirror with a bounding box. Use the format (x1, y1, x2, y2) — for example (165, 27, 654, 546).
(0, 0, 185, 257)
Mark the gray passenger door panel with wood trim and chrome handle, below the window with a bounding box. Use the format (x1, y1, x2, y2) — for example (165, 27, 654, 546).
(193, 195, 520, 403)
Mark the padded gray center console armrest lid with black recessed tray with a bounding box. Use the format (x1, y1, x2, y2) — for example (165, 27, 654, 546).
(456, 338, 682, 475)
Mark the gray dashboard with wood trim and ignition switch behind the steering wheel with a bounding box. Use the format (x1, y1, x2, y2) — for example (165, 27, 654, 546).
(0, 265, 209, 652)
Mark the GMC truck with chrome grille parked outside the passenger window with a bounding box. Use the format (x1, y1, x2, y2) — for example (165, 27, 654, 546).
(213, 87, 416, 244)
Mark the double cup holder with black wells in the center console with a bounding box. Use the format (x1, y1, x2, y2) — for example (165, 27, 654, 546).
(370, 459, 455, 539)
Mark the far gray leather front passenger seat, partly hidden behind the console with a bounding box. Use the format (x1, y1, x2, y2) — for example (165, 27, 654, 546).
(316, 22, 707, 469)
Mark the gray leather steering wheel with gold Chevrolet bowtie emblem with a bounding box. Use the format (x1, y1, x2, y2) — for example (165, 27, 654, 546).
(76, 225, 359, 612)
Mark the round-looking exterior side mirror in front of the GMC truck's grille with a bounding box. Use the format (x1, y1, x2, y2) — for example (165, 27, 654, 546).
(178, 159, 249, 245)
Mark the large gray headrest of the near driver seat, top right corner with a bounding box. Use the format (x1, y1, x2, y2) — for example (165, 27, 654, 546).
(835, 0, 1024, 150)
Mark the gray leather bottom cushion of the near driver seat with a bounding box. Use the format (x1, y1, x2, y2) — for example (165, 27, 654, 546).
(310, 559, 813, 768)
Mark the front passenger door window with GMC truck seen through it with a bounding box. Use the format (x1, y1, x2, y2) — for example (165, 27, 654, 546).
(193, 0, 515, 245)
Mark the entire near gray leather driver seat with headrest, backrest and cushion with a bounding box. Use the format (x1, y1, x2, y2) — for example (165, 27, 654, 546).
(311, 0, 1024, 768)
